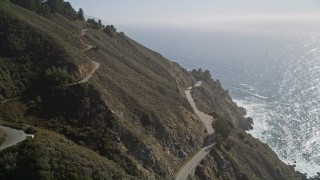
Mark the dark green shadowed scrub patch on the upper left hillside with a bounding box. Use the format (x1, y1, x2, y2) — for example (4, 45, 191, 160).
(0, 8, 68, 99)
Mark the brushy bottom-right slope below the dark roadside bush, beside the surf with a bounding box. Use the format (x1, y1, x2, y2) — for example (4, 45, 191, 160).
(195, 125, 306, 180)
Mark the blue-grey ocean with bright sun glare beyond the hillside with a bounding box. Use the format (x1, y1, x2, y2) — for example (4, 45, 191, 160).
(123, 20, 320, 177)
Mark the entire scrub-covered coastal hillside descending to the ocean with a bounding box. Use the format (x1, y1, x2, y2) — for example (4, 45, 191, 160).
(0, 1, 304, 179)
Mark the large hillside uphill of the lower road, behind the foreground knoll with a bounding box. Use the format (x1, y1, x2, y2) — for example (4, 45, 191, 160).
(0, 1, 205, 178)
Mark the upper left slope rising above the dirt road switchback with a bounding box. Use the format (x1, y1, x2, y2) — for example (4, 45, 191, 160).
(0, 2, 91, 100)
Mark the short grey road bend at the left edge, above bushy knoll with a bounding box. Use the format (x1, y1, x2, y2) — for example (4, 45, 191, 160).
(0, 125, 27, 151)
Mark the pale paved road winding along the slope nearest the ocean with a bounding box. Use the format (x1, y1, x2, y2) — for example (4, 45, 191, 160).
(176, 81, 215, 180)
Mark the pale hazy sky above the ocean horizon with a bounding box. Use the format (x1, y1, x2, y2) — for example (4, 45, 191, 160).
(70, 0, 320, 27)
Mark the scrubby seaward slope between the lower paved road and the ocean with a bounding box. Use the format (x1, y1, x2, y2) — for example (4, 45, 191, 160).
(182, 76, 306, 180)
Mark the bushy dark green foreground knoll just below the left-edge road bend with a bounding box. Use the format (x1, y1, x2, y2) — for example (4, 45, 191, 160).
(0, 129, 132, 180)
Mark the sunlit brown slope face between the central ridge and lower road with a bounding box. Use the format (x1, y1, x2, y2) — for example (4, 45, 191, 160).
(72, 25, 204, 176)
